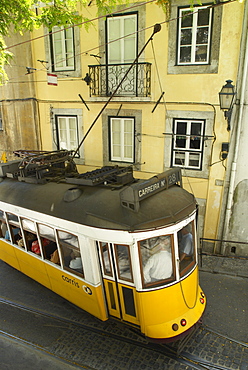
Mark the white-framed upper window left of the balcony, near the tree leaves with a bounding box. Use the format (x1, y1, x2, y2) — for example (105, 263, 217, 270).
(51, 26, 75, 72)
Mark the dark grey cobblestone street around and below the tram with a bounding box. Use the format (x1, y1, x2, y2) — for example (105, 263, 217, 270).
(0, 261, 248, 370)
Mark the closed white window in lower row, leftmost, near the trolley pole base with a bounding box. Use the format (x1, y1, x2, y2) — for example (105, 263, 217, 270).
(55, 115, 79, 156)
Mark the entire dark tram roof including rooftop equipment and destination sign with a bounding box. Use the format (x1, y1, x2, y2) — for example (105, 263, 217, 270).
(0, 150, 196, 231)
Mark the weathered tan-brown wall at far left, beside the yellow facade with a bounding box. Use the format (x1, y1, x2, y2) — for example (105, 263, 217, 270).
(0, 34, 40, 160)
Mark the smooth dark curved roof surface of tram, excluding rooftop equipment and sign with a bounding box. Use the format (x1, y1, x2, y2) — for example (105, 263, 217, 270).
(0, 178, 196, 231)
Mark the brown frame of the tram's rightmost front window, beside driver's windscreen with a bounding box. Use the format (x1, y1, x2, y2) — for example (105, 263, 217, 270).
(176, 220, 197, 278)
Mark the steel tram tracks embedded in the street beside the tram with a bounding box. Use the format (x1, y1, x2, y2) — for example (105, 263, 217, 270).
(0, 298, 248, 370)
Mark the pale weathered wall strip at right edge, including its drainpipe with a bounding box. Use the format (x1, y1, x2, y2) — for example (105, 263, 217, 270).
(219, 2, 248, 256)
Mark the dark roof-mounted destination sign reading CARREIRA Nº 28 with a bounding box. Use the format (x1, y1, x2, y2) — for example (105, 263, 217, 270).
(121, 168, 182, 210)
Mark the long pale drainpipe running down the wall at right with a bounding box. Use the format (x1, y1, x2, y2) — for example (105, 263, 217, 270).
(221, 1, 248, 254)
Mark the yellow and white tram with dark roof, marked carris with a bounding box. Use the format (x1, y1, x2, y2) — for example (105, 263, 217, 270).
(0, 151, 206, 341)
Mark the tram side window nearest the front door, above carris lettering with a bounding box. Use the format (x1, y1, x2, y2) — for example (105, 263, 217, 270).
(58, 230, 84, 277)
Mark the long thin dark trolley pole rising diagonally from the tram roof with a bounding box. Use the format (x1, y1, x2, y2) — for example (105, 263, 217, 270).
(72, 23, 161, 159)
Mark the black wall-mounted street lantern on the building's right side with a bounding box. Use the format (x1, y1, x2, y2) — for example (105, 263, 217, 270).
(219, 80, 236, 131)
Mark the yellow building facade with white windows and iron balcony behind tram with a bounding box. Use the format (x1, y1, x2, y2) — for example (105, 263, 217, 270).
(0, 0, 244, 251)
